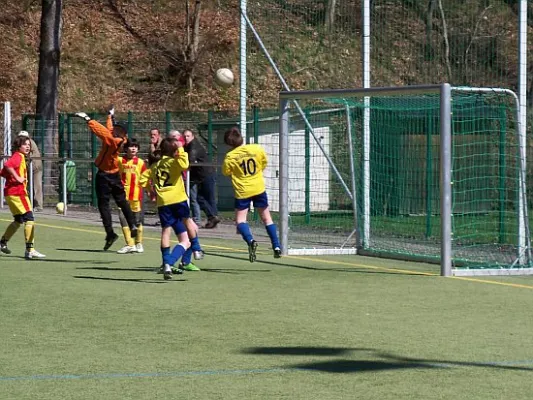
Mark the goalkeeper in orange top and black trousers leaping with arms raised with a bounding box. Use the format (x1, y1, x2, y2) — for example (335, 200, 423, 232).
(75, 107, 137, 250)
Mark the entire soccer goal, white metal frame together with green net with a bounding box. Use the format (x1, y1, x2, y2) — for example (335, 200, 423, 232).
(276, 84, 531, 275)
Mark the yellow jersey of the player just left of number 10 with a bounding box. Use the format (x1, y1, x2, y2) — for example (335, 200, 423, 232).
(139, 147, 189, 207)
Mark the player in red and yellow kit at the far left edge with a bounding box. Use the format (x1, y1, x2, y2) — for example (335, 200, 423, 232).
(0, 136, 46, 260)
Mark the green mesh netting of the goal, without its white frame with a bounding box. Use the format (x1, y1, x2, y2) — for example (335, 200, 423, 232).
(280, 88, 521, 268)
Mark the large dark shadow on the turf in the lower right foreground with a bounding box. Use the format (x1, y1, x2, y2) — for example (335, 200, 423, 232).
(242, 346, 533, 373)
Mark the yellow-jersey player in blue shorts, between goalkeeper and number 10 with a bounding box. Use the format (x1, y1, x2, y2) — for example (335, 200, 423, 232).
(141, 138, 203, 280)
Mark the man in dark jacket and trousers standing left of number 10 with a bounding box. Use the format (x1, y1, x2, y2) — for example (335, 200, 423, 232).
(183, 129, 220, 229)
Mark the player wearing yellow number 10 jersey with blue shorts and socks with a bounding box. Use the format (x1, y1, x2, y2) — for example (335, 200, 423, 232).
(222, 127, 281, 262)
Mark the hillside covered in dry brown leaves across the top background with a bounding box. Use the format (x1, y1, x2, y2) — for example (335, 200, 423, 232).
(0, 0, 533, 116)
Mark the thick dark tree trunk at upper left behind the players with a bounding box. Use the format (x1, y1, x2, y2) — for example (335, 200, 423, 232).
(35, 0, 63, 202)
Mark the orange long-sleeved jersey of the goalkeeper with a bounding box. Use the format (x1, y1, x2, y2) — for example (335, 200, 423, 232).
(88, 116, 126, 174)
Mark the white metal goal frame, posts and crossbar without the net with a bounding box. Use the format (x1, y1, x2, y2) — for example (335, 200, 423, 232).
(279, 83, 533, 276)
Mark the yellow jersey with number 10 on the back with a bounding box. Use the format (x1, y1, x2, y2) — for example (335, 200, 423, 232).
(222, 144, 267, 199)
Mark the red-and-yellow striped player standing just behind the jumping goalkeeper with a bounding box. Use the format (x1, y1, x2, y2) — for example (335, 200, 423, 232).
(117, 139, 146, 254)
